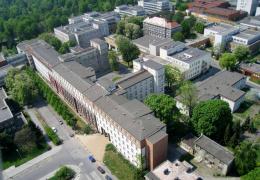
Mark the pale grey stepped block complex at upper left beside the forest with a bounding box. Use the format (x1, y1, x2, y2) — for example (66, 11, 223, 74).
(54, 12, 120, 48)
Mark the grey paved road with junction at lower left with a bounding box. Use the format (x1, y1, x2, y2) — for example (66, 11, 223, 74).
(3, 101, 116, 180)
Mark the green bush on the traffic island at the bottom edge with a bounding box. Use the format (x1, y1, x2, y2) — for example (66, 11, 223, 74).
(50, 166, 76, 180)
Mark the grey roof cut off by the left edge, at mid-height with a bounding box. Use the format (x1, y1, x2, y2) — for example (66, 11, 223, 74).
(0, 87, 13, 122)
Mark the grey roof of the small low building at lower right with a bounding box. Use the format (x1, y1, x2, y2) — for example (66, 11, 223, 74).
(194, 135, 234, 165)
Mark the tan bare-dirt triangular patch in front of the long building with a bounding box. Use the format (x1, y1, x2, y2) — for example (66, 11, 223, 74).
(76, 134, 109, 162)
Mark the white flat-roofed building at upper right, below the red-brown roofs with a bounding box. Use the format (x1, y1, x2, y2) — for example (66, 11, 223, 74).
(204, 23, 240, 47)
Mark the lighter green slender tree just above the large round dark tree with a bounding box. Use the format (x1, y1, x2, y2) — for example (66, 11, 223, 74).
(179, 81, 198, 117)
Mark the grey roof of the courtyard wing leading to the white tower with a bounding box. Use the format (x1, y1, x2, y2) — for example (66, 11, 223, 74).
(117, 70, 153, 89)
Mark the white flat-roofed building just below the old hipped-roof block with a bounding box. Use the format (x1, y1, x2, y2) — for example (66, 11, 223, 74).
(134, 36, 212, 80)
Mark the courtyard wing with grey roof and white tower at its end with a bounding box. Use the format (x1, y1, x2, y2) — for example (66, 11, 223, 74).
(116, 58, 164, 101)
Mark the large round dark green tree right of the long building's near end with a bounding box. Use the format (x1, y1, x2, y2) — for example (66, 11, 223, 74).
(191, 100, 232, 143)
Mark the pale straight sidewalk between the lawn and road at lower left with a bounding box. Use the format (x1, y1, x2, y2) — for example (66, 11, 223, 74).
(3, 146, 62, 179)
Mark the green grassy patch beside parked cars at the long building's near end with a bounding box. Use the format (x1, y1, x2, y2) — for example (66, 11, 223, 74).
(103, 145, 140, 180)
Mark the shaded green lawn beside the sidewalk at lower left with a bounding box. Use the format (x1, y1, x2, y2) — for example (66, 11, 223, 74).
(3, 144, 49, 169)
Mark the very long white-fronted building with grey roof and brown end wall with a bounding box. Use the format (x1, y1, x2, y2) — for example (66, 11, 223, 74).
(17, 40, 168, 169)
